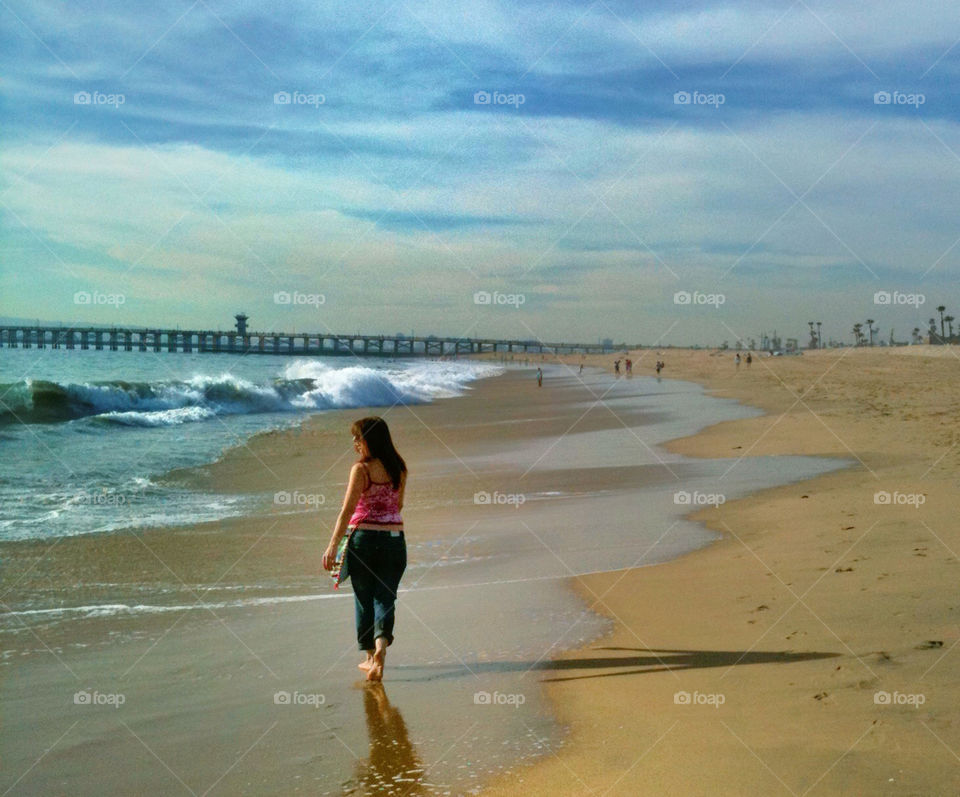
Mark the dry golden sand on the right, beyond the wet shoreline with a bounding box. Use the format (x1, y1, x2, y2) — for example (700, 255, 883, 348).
(484, 346, 960, 795)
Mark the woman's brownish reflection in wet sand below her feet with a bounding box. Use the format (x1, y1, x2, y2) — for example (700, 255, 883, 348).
(357, 683, 426, 797)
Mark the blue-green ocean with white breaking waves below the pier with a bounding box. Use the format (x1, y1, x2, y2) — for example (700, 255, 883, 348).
(0, 349, 502, 542)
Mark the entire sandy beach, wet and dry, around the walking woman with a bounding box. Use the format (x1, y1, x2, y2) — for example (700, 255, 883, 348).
(2, 349, 960, 794)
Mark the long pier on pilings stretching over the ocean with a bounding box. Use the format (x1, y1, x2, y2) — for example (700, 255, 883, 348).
(0, 325, 614, 357)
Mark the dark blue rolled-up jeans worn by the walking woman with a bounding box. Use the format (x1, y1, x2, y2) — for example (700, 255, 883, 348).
(347, 529, 407, 650)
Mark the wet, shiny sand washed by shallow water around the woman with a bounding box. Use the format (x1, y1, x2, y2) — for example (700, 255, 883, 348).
(2, 369, 846, 794)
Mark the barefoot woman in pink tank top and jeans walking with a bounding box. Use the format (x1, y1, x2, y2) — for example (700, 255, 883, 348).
(323, 417, 407, 681)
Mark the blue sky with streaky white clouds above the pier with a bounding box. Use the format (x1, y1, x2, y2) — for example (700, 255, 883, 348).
(0, 0, 960, 345)
